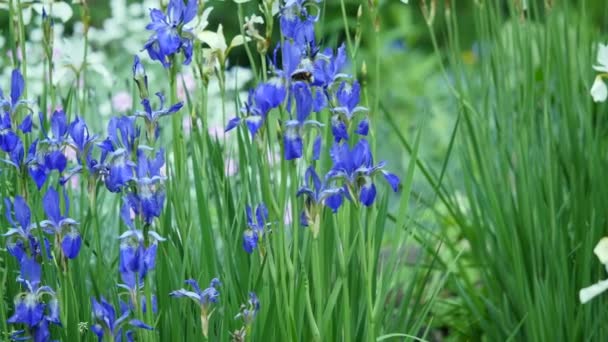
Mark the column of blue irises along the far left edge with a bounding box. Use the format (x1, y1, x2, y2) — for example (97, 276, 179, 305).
(0, 69, 81, 341)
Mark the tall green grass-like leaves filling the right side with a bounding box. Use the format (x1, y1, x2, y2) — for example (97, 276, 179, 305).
(414, 1, 608, 341)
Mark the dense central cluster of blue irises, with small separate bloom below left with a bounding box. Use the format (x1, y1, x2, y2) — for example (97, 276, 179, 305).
(226, 0, 400, 243)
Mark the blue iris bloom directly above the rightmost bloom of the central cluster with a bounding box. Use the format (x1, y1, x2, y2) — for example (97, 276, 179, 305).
(331, 81, 369, 142)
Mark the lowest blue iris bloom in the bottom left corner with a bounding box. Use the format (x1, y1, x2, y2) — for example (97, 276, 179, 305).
(7, 257, 61, 342)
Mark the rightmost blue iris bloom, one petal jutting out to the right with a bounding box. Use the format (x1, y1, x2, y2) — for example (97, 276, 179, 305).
(328, 139, 400, 206)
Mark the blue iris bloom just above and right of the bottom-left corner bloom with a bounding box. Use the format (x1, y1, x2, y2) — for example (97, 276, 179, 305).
(40, 188, 82, 259)
